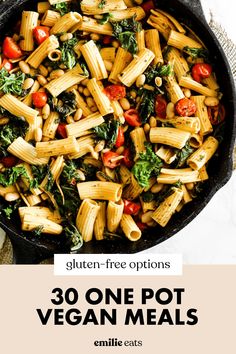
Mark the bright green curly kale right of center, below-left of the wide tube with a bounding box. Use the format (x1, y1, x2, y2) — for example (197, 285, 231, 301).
(132, 144, 162, 188)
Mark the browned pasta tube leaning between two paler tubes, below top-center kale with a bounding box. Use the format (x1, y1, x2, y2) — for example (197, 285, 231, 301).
(109, 47, 132, 84)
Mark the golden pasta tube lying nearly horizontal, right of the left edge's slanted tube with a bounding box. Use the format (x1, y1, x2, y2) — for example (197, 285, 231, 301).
(36, 136, 79, 157)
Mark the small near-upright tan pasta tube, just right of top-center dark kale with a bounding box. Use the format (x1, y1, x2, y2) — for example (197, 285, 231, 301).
(145, 29, 164, 65)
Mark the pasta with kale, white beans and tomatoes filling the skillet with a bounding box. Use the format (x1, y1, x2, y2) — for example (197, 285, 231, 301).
(0, 0, 225, 251)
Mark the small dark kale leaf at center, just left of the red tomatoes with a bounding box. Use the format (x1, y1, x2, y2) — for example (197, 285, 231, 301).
(93, 118, 120, 148)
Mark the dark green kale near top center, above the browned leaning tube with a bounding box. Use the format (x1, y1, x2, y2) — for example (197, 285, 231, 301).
(112, 16, 142, 54)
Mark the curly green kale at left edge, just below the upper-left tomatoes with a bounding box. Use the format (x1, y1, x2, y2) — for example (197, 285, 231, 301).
(0, 68, 25, 96)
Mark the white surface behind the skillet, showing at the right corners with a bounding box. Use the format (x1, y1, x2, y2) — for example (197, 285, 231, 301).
(0, 0, 236, 264)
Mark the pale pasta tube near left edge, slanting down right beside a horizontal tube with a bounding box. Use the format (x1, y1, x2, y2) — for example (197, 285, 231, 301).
(7, 137, 48, 165)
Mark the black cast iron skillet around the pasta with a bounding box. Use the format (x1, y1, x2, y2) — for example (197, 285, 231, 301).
(0, 0, 236, 264)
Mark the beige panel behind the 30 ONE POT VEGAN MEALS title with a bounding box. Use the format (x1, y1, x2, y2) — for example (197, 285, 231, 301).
(0, 265, 236, 354)
